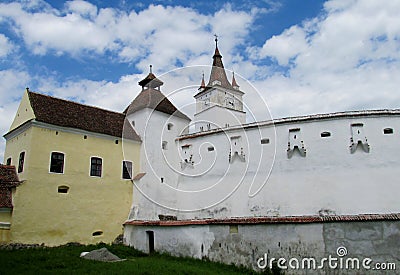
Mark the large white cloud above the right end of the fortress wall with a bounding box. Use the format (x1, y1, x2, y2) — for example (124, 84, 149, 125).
(249, 0, 400, 117)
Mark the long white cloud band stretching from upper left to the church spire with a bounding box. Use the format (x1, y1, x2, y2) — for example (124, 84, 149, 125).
(0, 1, 261, 71)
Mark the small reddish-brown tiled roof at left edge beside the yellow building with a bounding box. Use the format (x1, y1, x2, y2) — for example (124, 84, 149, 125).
(0, 164, 21, 208)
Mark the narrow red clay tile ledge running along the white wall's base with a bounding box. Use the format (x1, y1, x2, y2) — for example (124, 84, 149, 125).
(124, 213, 400, 226)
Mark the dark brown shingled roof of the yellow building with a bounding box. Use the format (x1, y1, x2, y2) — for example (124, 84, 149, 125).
(28, 91, 141, 141)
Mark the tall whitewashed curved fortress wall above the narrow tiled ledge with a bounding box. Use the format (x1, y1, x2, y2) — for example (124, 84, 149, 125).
(126, 111, 400, 220)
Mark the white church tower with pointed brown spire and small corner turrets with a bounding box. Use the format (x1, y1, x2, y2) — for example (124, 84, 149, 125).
(194, 36, 246, 132)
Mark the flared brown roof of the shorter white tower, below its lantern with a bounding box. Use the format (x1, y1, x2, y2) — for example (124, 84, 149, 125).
(124, 88, 190, 120)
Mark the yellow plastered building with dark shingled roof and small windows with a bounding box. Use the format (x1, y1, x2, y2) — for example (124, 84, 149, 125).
(0, 89, 141, 246)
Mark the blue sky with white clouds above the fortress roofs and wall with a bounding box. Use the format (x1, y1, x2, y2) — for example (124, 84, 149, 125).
(0, 0, 400, 160)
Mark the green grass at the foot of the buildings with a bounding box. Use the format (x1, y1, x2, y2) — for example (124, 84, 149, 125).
(0, 244, 280, 275)
